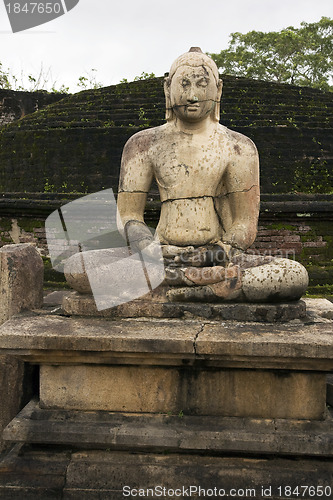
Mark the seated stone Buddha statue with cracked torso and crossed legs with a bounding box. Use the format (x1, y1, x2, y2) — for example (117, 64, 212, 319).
(64, 47, 308, 302)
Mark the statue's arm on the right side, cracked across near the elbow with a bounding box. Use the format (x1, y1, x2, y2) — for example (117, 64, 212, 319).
(221, 139, 260, 250)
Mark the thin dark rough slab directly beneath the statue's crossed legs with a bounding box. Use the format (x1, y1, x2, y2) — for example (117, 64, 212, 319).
(62, 292, 306, 323)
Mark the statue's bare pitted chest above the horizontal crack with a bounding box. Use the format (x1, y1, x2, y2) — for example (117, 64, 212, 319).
(153, 140, 225, 188)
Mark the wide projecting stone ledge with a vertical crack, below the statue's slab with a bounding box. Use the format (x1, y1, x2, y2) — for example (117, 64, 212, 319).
(0, 314, 333, 372)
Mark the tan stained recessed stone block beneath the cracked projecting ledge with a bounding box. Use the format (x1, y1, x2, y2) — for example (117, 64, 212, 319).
(40, 364, 326, 420)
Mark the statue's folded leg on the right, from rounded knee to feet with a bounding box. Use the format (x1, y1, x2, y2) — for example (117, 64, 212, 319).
(166, 256, 308, 302)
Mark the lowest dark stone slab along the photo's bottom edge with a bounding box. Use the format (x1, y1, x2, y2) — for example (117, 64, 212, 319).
(0, 446, 333, 500)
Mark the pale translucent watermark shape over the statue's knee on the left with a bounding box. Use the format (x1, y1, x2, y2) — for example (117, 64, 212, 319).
(45, 189, 165, 311)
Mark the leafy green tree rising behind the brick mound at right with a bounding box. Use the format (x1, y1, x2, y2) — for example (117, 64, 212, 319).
(209, 17, 333, 90)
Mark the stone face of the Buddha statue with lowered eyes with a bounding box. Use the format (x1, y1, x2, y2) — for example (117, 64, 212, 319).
(170, 65, 218, 123)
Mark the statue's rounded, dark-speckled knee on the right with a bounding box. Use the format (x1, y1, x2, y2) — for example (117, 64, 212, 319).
(242, 259, 309, 302)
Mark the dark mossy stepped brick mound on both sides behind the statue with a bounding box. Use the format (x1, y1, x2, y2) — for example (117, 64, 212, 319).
(0, 75, 333, 193)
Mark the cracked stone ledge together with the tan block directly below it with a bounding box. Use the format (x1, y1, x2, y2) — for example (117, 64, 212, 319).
(0, 315, 333, 426)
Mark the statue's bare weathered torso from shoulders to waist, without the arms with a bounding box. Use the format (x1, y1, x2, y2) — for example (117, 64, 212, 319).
(145, 124, 254, 246)
